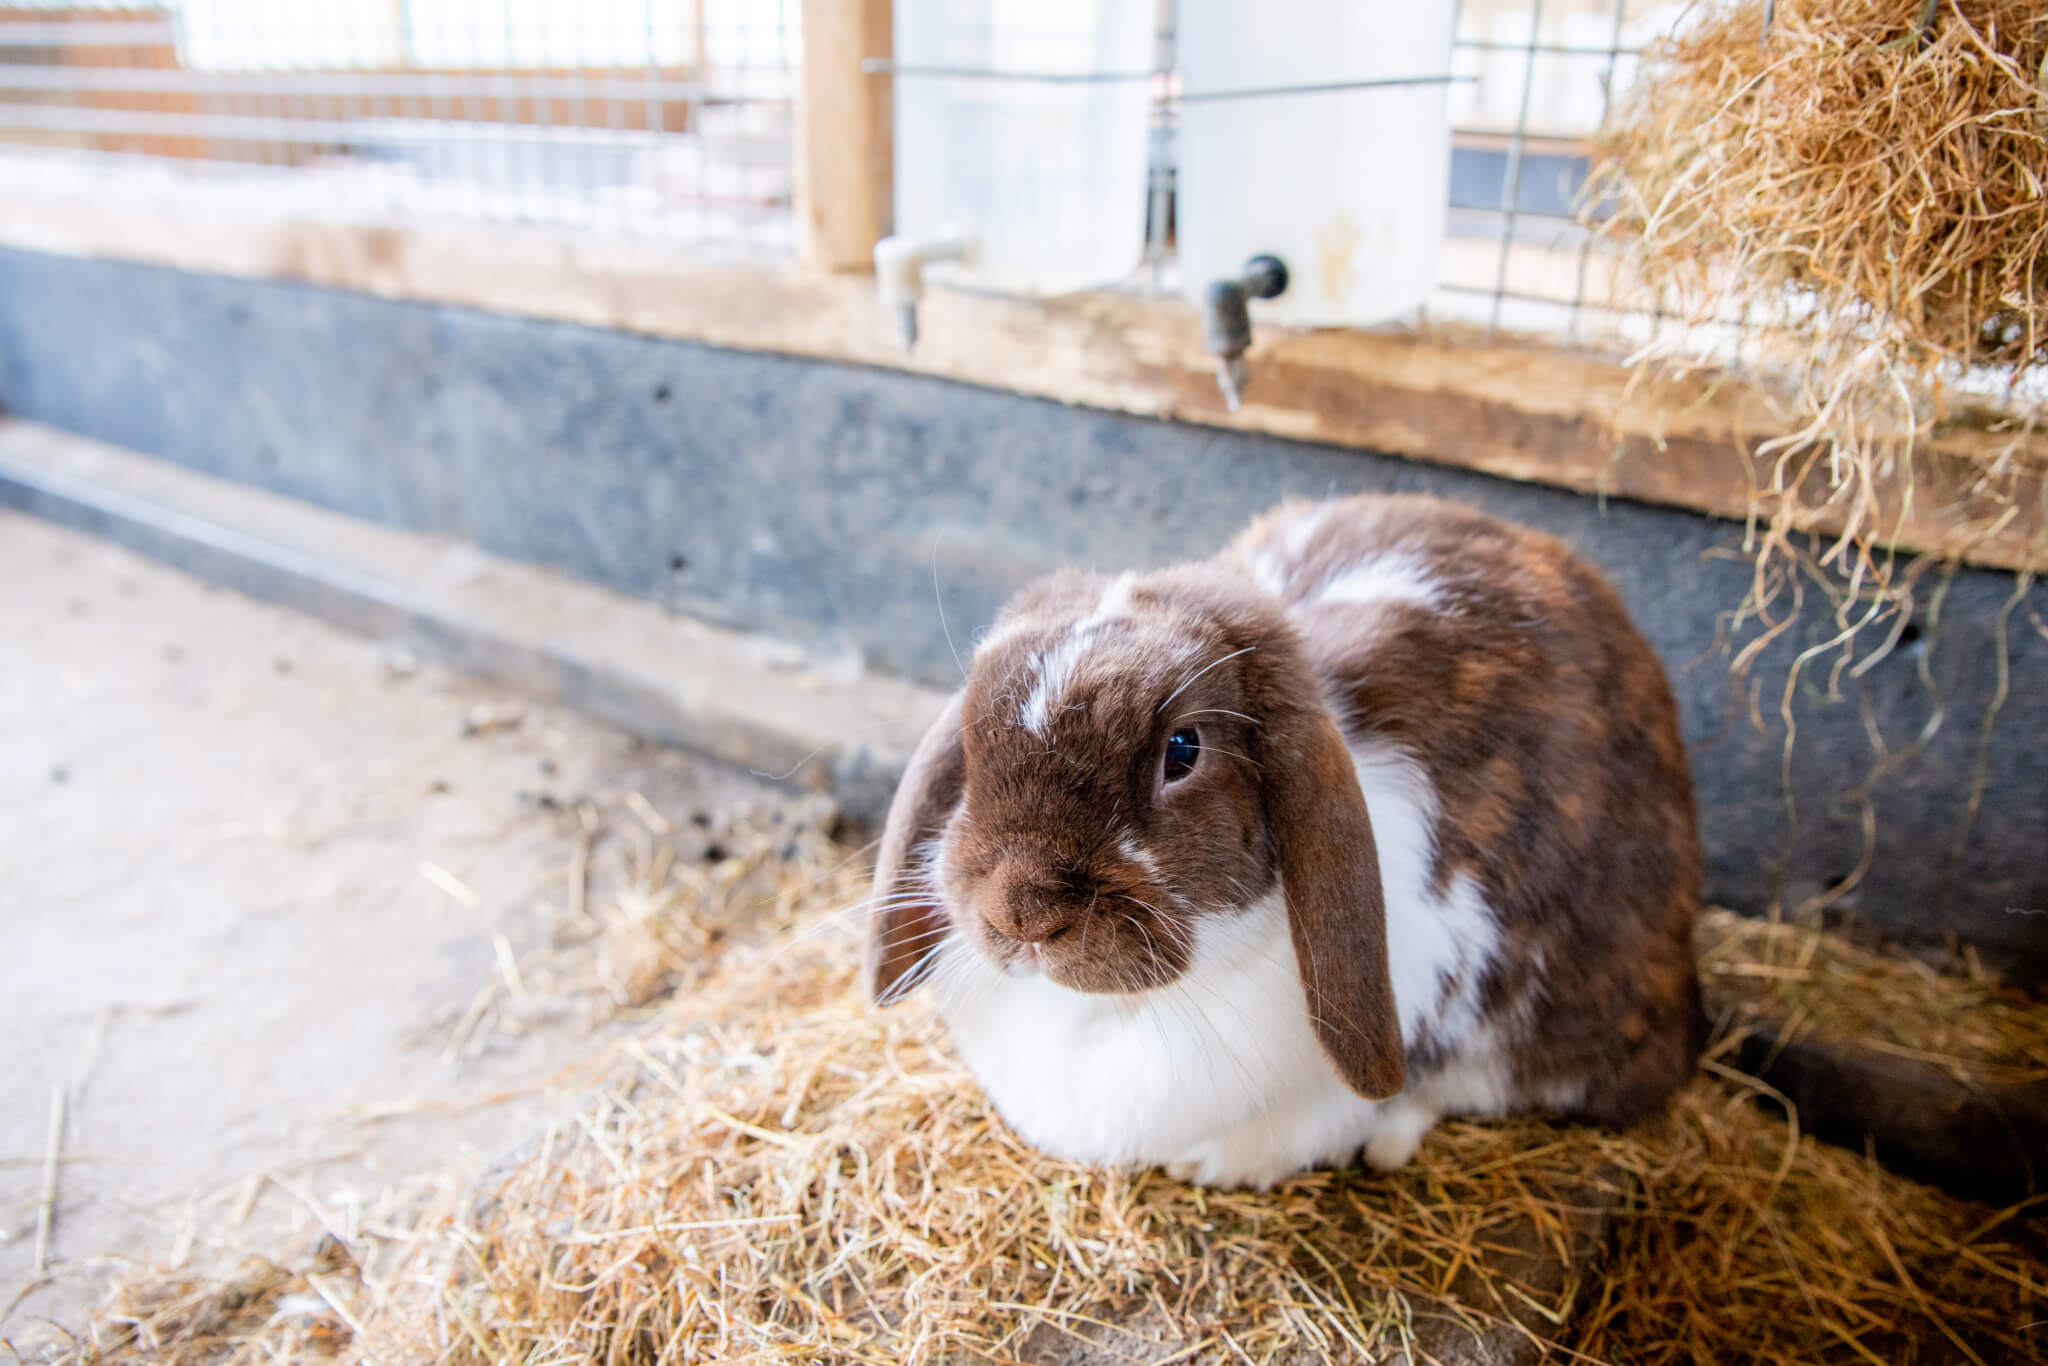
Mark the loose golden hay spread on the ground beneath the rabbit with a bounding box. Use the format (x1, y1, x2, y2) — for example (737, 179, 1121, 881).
(51, 870, 2048, 1366)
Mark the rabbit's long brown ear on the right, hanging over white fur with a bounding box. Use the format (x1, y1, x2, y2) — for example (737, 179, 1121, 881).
(1247, 645, 1405, 1100)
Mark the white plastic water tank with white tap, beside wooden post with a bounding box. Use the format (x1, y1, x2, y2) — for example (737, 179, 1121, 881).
(895, 0, 1157, 295)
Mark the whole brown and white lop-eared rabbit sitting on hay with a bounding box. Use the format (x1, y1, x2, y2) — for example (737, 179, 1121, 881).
(868, 496, 1704, 1186)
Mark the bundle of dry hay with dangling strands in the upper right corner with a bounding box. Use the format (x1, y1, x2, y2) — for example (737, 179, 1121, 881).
(1591, 0, 2048, 598)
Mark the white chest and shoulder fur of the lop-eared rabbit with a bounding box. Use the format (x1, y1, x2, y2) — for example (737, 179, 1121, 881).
(938, 739, 1511, 1186)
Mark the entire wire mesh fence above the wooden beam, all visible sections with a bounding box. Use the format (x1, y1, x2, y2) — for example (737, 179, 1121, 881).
(0, 0, 1679, 344)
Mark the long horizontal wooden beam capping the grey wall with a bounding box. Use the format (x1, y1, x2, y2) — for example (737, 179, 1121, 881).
(0, 174, 2048, 569)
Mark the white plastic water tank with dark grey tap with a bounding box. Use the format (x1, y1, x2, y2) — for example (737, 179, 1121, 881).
(1176, 0, 1452, 326)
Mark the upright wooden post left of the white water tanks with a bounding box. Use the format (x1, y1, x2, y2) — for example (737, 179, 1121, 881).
(797, 0, 895, 270)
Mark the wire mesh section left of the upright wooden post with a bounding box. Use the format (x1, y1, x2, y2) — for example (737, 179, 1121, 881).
(0, 0, 801, 250)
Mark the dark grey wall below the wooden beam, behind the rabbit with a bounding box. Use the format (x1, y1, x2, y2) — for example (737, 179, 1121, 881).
(0, 250, 2048, 979)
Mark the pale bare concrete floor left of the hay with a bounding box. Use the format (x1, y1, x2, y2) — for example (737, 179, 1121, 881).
(0, 512, 815, 1348)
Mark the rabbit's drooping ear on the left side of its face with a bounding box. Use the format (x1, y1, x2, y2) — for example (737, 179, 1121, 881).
(866, 692, 967, 1006)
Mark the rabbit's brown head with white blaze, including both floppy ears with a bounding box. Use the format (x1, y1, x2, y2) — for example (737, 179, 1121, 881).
(868, 567, 1403, 1096)
